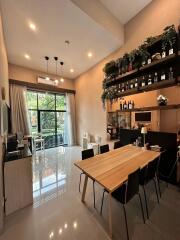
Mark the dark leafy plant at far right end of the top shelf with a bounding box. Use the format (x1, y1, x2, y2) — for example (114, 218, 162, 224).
(162, 25, 177, 57)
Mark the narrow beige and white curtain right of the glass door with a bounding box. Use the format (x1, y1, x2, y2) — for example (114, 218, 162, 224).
(65, 93, 76, 146)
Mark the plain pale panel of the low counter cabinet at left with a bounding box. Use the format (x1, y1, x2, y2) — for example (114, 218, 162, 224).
(4, 157, 33, 215)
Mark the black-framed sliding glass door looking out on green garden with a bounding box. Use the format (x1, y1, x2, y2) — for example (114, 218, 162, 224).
(27, 91, 67, 148)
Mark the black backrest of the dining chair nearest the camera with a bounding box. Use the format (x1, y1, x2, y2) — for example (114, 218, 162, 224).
(125, 169, 140, 203)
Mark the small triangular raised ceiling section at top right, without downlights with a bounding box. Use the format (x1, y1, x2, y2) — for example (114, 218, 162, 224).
(100, 0, 152, 24)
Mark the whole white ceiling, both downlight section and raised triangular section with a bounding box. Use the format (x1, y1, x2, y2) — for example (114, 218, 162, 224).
(0, 0, 150, 78)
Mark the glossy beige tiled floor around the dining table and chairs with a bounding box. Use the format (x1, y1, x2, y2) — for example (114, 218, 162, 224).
(0, 147, 180, 240)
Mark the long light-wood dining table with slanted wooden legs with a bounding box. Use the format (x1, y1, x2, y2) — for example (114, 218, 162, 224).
(74, 145, 160, 239)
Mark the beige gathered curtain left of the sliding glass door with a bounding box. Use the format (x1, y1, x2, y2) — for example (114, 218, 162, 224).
(10, 84, 30, 135)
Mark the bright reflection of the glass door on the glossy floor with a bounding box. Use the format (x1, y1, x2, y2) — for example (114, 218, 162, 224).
(33, 147, 68, 207)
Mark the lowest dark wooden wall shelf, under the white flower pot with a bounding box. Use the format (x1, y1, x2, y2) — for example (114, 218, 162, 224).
(117, 104, 180, 112)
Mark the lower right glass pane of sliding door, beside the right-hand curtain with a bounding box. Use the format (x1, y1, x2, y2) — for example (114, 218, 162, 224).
(57, 112, 67, 146)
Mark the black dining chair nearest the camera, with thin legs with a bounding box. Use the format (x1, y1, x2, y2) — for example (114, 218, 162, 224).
(101, 169, 145, 239)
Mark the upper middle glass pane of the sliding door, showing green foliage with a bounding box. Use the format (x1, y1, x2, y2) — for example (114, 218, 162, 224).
(38, 93, 55, 110)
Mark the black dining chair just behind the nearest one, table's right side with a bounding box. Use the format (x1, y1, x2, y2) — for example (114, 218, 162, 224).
(139, 158, 160, 219)
